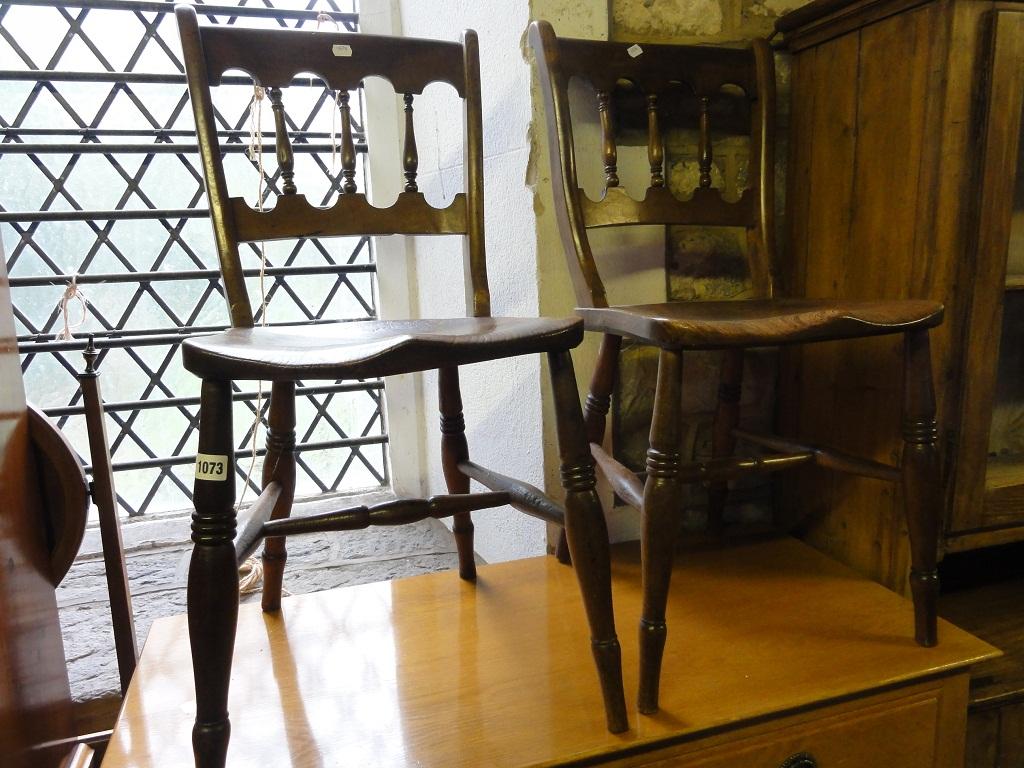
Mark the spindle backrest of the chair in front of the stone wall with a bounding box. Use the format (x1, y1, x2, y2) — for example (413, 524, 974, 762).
(529, 22, 775, 306)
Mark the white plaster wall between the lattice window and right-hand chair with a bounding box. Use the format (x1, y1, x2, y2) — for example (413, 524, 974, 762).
(382, 0, 546, 562)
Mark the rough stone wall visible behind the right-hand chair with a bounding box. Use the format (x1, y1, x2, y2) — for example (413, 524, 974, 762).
(610, 0, 806, 527)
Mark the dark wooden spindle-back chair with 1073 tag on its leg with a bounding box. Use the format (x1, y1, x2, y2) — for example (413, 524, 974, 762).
(176, 6, 627, 766)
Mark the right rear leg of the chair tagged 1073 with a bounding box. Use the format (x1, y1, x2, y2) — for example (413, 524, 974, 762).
(437, 367, 476, 582)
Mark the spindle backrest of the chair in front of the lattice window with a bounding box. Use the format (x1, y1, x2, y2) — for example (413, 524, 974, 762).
(175, 5, 490, 327)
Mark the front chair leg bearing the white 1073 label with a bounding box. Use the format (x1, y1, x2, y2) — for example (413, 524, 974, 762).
(188, 381, 239, 768)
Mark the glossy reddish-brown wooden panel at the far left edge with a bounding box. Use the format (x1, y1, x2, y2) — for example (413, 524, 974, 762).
(0, 243, 71, 768)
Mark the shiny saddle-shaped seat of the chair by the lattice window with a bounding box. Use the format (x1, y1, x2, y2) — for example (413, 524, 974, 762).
(182, 317, 583, 381)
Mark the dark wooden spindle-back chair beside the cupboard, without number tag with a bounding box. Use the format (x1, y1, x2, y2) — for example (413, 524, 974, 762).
(529, 22, 943, 714)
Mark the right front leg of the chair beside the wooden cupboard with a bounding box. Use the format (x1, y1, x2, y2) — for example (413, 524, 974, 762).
(902, 331, 942, 646)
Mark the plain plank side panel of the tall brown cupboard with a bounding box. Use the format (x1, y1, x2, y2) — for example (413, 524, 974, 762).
(777, 2, 958, 589)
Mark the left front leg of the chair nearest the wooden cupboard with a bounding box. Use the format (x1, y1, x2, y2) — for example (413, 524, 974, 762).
(637, 349, 683, 715)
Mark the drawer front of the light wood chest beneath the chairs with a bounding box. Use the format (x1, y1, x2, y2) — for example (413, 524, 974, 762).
(637, 694, 946, 768)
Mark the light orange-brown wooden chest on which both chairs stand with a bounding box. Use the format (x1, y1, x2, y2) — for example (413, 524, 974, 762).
(103, 539, 996, 768)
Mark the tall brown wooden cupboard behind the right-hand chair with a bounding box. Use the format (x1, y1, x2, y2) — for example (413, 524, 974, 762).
(777, 0, 1024, 590)
